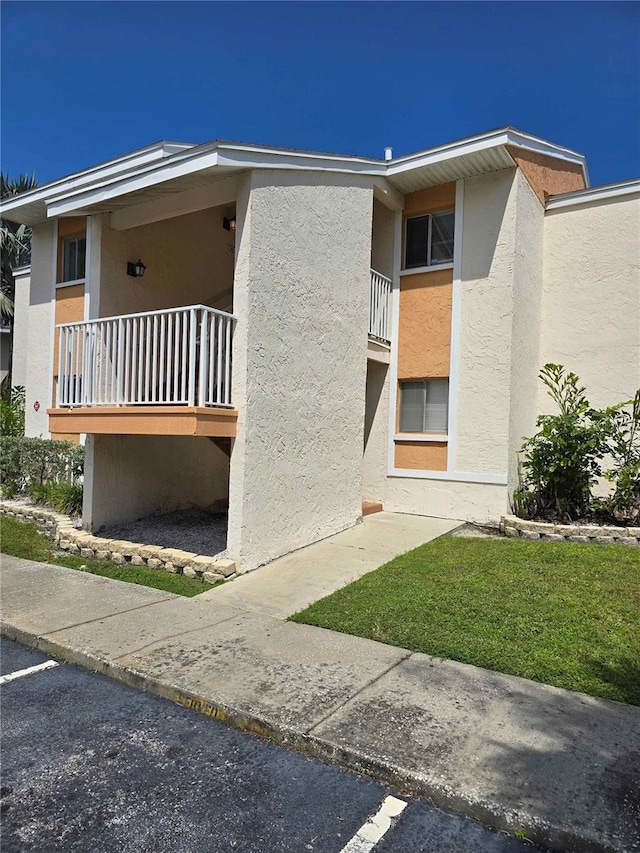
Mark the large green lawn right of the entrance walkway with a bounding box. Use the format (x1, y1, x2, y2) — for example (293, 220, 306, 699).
(291, 537, 640, 705)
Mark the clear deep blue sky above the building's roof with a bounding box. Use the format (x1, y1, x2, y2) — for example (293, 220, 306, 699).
(1, 2, 640, 185)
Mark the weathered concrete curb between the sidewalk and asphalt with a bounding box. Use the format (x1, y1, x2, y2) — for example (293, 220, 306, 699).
(0, 621, 625, 853)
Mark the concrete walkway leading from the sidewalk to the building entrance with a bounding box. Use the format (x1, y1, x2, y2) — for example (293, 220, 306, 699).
(199, 512, 462, 619)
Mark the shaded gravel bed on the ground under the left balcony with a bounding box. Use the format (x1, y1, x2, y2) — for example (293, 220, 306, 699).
(97, 509, 227, 557)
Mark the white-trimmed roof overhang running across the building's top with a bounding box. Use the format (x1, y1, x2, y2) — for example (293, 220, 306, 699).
(2, 127, 588, 225)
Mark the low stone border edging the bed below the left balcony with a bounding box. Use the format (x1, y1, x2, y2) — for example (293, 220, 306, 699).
(0, 500, 237, 584)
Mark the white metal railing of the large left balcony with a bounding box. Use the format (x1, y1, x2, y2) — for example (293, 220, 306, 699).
(57, 305, 235, 407)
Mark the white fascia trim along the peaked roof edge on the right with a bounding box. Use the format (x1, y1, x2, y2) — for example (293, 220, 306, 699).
(387, 128, 588, 180)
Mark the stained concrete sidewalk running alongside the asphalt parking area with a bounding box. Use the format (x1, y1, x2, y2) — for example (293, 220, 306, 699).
(2, 557, 640, 852)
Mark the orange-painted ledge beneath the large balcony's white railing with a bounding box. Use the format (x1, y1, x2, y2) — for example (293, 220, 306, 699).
(47, 406, 238, 438)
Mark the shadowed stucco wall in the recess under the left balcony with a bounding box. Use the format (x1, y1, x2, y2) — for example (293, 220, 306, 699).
(83, 435, 229, 532)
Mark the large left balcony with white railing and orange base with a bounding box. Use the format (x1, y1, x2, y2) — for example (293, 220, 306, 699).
(49, 305, 237, 437)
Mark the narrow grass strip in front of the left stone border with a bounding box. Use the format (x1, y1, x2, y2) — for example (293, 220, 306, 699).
(0, 516, 213, 597)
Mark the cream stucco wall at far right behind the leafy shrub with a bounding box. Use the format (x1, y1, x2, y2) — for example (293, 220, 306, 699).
(538, 195, 640, 411)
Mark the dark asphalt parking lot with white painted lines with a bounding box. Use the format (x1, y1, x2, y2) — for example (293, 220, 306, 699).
(0, 638, 539, 853)
